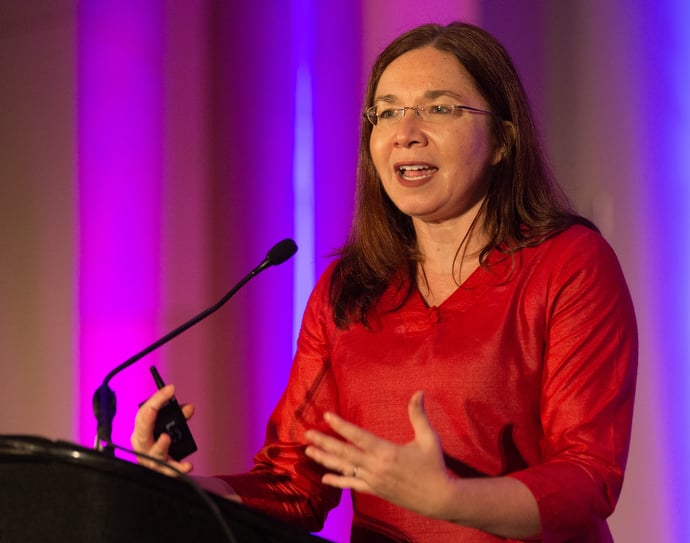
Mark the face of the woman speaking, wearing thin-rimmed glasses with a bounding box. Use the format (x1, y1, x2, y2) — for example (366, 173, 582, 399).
(369, 46, 500, 226)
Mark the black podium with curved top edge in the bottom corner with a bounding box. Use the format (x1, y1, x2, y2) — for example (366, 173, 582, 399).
(0, 436, 332, 543)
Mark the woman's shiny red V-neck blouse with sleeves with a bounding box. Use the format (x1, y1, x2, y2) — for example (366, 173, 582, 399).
(222, 226, 637, 543)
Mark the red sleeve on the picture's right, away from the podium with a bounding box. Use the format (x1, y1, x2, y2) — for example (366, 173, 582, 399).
(511, 229, 637, 542)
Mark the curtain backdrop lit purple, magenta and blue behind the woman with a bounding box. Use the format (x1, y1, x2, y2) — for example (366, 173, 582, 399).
(0, 0, 690, 543)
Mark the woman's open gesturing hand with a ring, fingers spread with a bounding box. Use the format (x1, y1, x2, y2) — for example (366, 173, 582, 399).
(305, 391, 454, 520)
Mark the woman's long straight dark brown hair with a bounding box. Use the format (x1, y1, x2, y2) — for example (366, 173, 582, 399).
(330, 23, 595, 328)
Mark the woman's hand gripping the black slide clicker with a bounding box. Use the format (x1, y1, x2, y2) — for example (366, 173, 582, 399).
(131, 385, 194, 475)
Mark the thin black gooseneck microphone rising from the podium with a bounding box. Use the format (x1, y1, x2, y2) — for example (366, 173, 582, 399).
(93, 238, 297, 456)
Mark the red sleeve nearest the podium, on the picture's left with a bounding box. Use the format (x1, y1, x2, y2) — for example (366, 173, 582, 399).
(215, 266, 341, 531)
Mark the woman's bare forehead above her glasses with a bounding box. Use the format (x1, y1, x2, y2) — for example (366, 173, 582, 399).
(374, 46, 480, 100)
